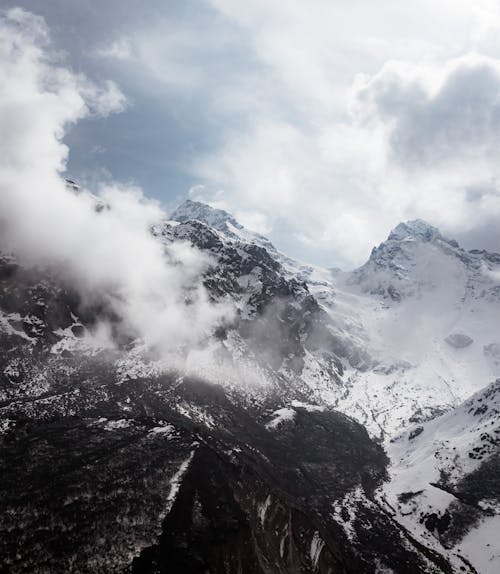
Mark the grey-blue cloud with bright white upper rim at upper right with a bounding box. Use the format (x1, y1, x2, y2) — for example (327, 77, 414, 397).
(357, 54, 500, 168)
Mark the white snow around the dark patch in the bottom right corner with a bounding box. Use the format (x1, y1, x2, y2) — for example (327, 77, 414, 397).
(378, 381, 500, 574)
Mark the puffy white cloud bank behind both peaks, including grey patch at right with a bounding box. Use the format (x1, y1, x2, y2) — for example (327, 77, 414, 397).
(195, 27, 500, 267)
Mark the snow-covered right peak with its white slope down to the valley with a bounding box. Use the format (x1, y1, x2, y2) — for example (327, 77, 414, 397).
(330, 221, 500, 436)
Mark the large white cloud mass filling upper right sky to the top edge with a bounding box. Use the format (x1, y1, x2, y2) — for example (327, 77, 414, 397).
(188, 0, 500, 266)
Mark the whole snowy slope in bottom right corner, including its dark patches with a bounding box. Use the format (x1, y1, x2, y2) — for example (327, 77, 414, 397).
(381, 380, 500, 574)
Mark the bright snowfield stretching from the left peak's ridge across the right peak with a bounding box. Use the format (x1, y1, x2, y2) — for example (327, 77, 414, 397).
(167, 205, 500, 437)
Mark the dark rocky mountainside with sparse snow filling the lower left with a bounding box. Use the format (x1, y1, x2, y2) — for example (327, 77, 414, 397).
(0, 254, 464, 574)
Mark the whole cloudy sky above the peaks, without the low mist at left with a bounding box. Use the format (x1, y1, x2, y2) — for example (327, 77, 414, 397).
(0, 0, 500, 268)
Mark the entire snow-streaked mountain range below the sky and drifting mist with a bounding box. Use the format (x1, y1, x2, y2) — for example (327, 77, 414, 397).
(0, 199, 500, 574)
